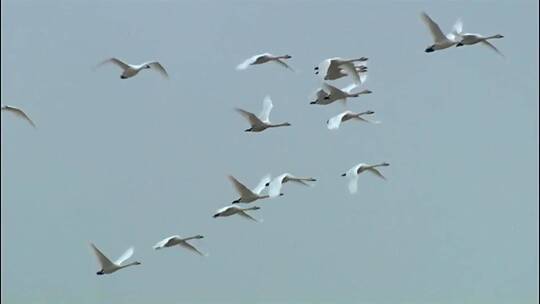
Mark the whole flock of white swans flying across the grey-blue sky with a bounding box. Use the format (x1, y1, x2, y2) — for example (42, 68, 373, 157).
(1, 13, 503, 275)
